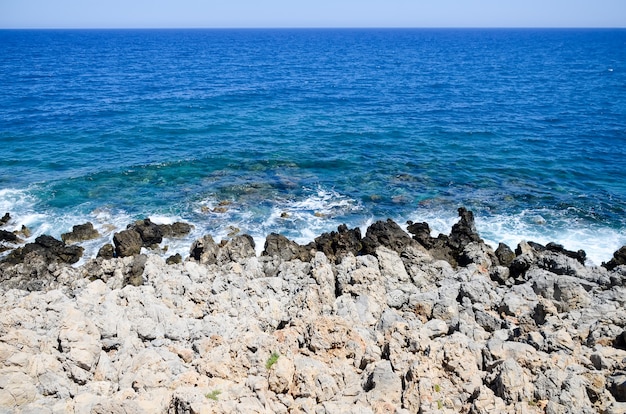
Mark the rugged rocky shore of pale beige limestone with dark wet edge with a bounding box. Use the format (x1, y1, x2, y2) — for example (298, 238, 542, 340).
(0, 208, 626, 414)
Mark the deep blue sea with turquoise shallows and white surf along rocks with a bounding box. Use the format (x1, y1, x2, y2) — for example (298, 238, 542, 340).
(0, 29, 626, 265)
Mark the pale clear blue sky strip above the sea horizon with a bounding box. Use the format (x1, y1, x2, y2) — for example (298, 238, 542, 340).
(0, 0, 626, 28)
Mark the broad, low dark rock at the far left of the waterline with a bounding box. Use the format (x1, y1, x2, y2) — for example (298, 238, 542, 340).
(3, 235, 83, 264)
